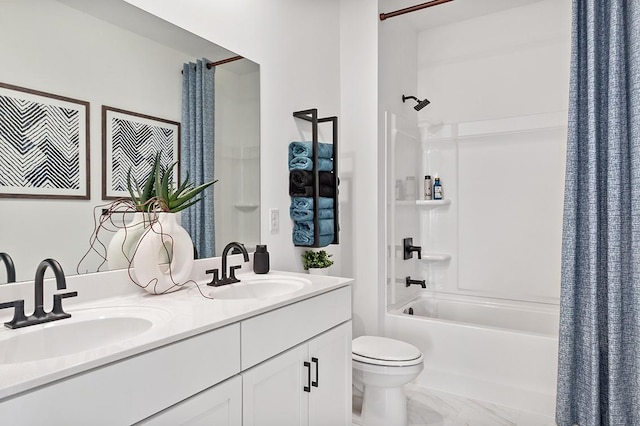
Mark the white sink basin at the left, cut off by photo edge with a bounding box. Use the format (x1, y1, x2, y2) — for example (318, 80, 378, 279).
(0, 306, 171, 364)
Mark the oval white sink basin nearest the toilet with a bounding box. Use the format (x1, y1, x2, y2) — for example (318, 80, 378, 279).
(208, 275, 311, 300)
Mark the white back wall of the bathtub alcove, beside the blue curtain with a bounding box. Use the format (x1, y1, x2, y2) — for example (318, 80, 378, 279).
(418, 0, 571, 303)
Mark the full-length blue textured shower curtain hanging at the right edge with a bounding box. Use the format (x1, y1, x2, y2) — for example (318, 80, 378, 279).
(556, 0, 640, 426)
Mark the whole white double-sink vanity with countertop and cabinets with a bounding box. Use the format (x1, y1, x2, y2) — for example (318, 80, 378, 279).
(0, 256, 352, 426)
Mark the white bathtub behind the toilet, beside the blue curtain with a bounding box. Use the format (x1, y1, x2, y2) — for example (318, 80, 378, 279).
(385, 293, 559, 416)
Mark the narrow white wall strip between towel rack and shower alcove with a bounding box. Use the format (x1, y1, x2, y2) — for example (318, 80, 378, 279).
(340, 0, 385, 337)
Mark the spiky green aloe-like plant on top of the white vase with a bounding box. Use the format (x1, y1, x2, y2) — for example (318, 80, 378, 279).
(127, 153, 217, 213)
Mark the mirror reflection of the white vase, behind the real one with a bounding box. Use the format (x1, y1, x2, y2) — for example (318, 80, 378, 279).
(107, 212, 149, 270)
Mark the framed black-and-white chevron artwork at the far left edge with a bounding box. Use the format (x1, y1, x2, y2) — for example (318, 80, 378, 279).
(0, 83, 89, 200)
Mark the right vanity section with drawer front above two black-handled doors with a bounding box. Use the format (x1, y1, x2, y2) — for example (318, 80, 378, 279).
(241, 287, 351, 426)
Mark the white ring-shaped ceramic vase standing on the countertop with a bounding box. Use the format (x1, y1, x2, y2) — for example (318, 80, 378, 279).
(133, 213, 194, 294)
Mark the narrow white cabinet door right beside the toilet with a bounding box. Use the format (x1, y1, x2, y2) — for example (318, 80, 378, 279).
(308, 321, 351, 426)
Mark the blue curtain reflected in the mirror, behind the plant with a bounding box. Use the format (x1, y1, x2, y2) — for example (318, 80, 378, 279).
(180, 59, 215, 258)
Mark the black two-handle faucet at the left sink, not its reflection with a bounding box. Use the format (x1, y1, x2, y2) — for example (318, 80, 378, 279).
(0, 259, 78, 328)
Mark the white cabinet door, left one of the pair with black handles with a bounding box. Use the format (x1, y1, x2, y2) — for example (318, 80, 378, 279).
(242, 345, 308, 426)
